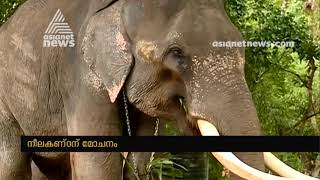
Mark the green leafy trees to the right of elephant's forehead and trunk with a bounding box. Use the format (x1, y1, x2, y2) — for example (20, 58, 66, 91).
(226, 0, 320, 174)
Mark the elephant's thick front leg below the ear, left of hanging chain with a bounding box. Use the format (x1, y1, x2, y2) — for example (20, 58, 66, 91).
(66, 81, 122, 180)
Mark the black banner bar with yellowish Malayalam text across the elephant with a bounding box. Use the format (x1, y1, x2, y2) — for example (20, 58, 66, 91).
(21, 136, 320, 152)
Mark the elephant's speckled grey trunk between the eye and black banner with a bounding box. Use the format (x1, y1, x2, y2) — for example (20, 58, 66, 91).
(186, 49, 260, 135)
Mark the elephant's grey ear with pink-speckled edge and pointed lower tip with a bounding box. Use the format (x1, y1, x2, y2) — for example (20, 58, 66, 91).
(81, 3, 133, 103)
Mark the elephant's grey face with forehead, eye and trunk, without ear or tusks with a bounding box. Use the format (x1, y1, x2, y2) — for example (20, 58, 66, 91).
(123, 0, 260, 135)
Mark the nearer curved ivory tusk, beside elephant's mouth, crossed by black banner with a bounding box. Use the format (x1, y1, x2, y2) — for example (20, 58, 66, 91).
(197, 120, 301, 180)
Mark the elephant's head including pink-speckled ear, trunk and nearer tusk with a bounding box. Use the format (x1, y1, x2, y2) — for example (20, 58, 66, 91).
(82, 0, 316, 179)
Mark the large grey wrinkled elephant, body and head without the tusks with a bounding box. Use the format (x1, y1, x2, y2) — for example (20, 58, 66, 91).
(0, 0, 263, 180)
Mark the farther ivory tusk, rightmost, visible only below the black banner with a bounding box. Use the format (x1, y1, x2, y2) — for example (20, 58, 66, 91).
(263, 152, 319, 180)
